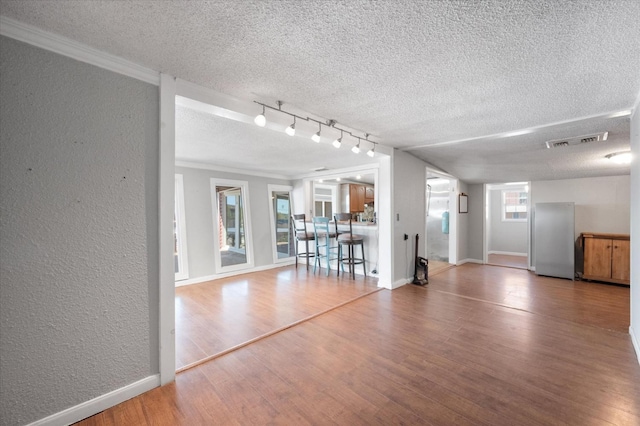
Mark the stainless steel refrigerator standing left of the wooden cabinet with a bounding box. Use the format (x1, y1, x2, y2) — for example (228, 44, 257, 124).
(533, 203, 575, 280)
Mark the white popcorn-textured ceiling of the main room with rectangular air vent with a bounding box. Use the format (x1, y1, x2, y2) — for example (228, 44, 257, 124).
(0, 0, 640, 182)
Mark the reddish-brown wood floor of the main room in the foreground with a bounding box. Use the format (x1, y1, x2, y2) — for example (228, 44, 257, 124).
(75, 264, 640, 425)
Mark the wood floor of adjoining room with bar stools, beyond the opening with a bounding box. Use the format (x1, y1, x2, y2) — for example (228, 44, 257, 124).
(176, 265, 378, 370)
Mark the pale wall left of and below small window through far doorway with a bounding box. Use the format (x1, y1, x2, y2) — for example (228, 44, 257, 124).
(487, 189, 527, 253)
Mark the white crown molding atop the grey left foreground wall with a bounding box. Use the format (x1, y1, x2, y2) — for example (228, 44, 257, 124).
(0, 16, 160, 86)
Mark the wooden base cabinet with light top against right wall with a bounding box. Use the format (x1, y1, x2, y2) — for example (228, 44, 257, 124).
(582, 232, 631, 285)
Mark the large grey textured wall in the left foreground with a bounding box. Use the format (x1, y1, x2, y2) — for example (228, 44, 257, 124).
(0, 37, 159, 425)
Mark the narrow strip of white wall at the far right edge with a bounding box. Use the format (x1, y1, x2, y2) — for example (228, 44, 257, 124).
(630, 108, 640, 362)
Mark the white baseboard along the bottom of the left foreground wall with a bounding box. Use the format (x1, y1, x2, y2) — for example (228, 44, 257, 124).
(29, 374, 160, 426)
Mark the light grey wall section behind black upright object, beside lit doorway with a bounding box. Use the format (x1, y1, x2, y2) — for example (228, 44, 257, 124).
(392, 150, 427, 283)
